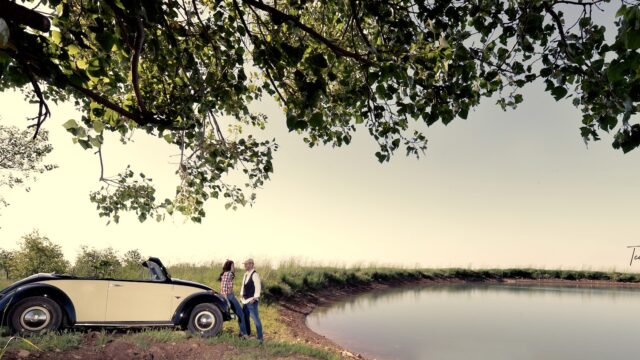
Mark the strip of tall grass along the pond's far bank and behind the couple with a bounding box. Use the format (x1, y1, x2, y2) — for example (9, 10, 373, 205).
(5, 260, 640, 301)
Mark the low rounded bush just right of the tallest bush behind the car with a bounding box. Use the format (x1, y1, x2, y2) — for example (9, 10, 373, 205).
(73, 245, 122, 278)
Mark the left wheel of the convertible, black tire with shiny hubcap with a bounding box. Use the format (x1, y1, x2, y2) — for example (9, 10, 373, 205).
(9, 296, 62, 335)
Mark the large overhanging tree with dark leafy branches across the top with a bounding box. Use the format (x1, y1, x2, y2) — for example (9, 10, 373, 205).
(0, 0, 640, 222)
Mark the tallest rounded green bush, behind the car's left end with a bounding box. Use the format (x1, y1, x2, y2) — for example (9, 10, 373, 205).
(11, 230, 69, 278)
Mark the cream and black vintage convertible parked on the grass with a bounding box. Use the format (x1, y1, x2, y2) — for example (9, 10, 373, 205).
(0, 258, 231, 336)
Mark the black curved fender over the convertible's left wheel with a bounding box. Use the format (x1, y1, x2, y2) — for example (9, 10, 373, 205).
(0, 283, 76, 326)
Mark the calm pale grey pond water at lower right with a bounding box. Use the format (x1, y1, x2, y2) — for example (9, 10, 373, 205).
(307, 285, 640, 360)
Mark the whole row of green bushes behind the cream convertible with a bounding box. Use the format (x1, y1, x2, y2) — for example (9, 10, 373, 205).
(0, 231, 143, 279)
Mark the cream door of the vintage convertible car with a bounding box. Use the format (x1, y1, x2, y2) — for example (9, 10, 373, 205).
(106, 280, 173, 323)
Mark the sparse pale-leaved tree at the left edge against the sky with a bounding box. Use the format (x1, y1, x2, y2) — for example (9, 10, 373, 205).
(0, 125, 56, 212)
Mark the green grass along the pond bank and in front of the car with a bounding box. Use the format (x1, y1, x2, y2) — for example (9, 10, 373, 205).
(0, 261, 640, 359)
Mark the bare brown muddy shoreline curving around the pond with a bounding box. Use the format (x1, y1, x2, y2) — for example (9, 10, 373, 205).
(278, 278, 640, 359)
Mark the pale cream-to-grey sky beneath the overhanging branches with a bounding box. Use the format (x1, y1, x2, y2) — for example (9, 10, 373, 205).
(0, 2, 640, 271)
